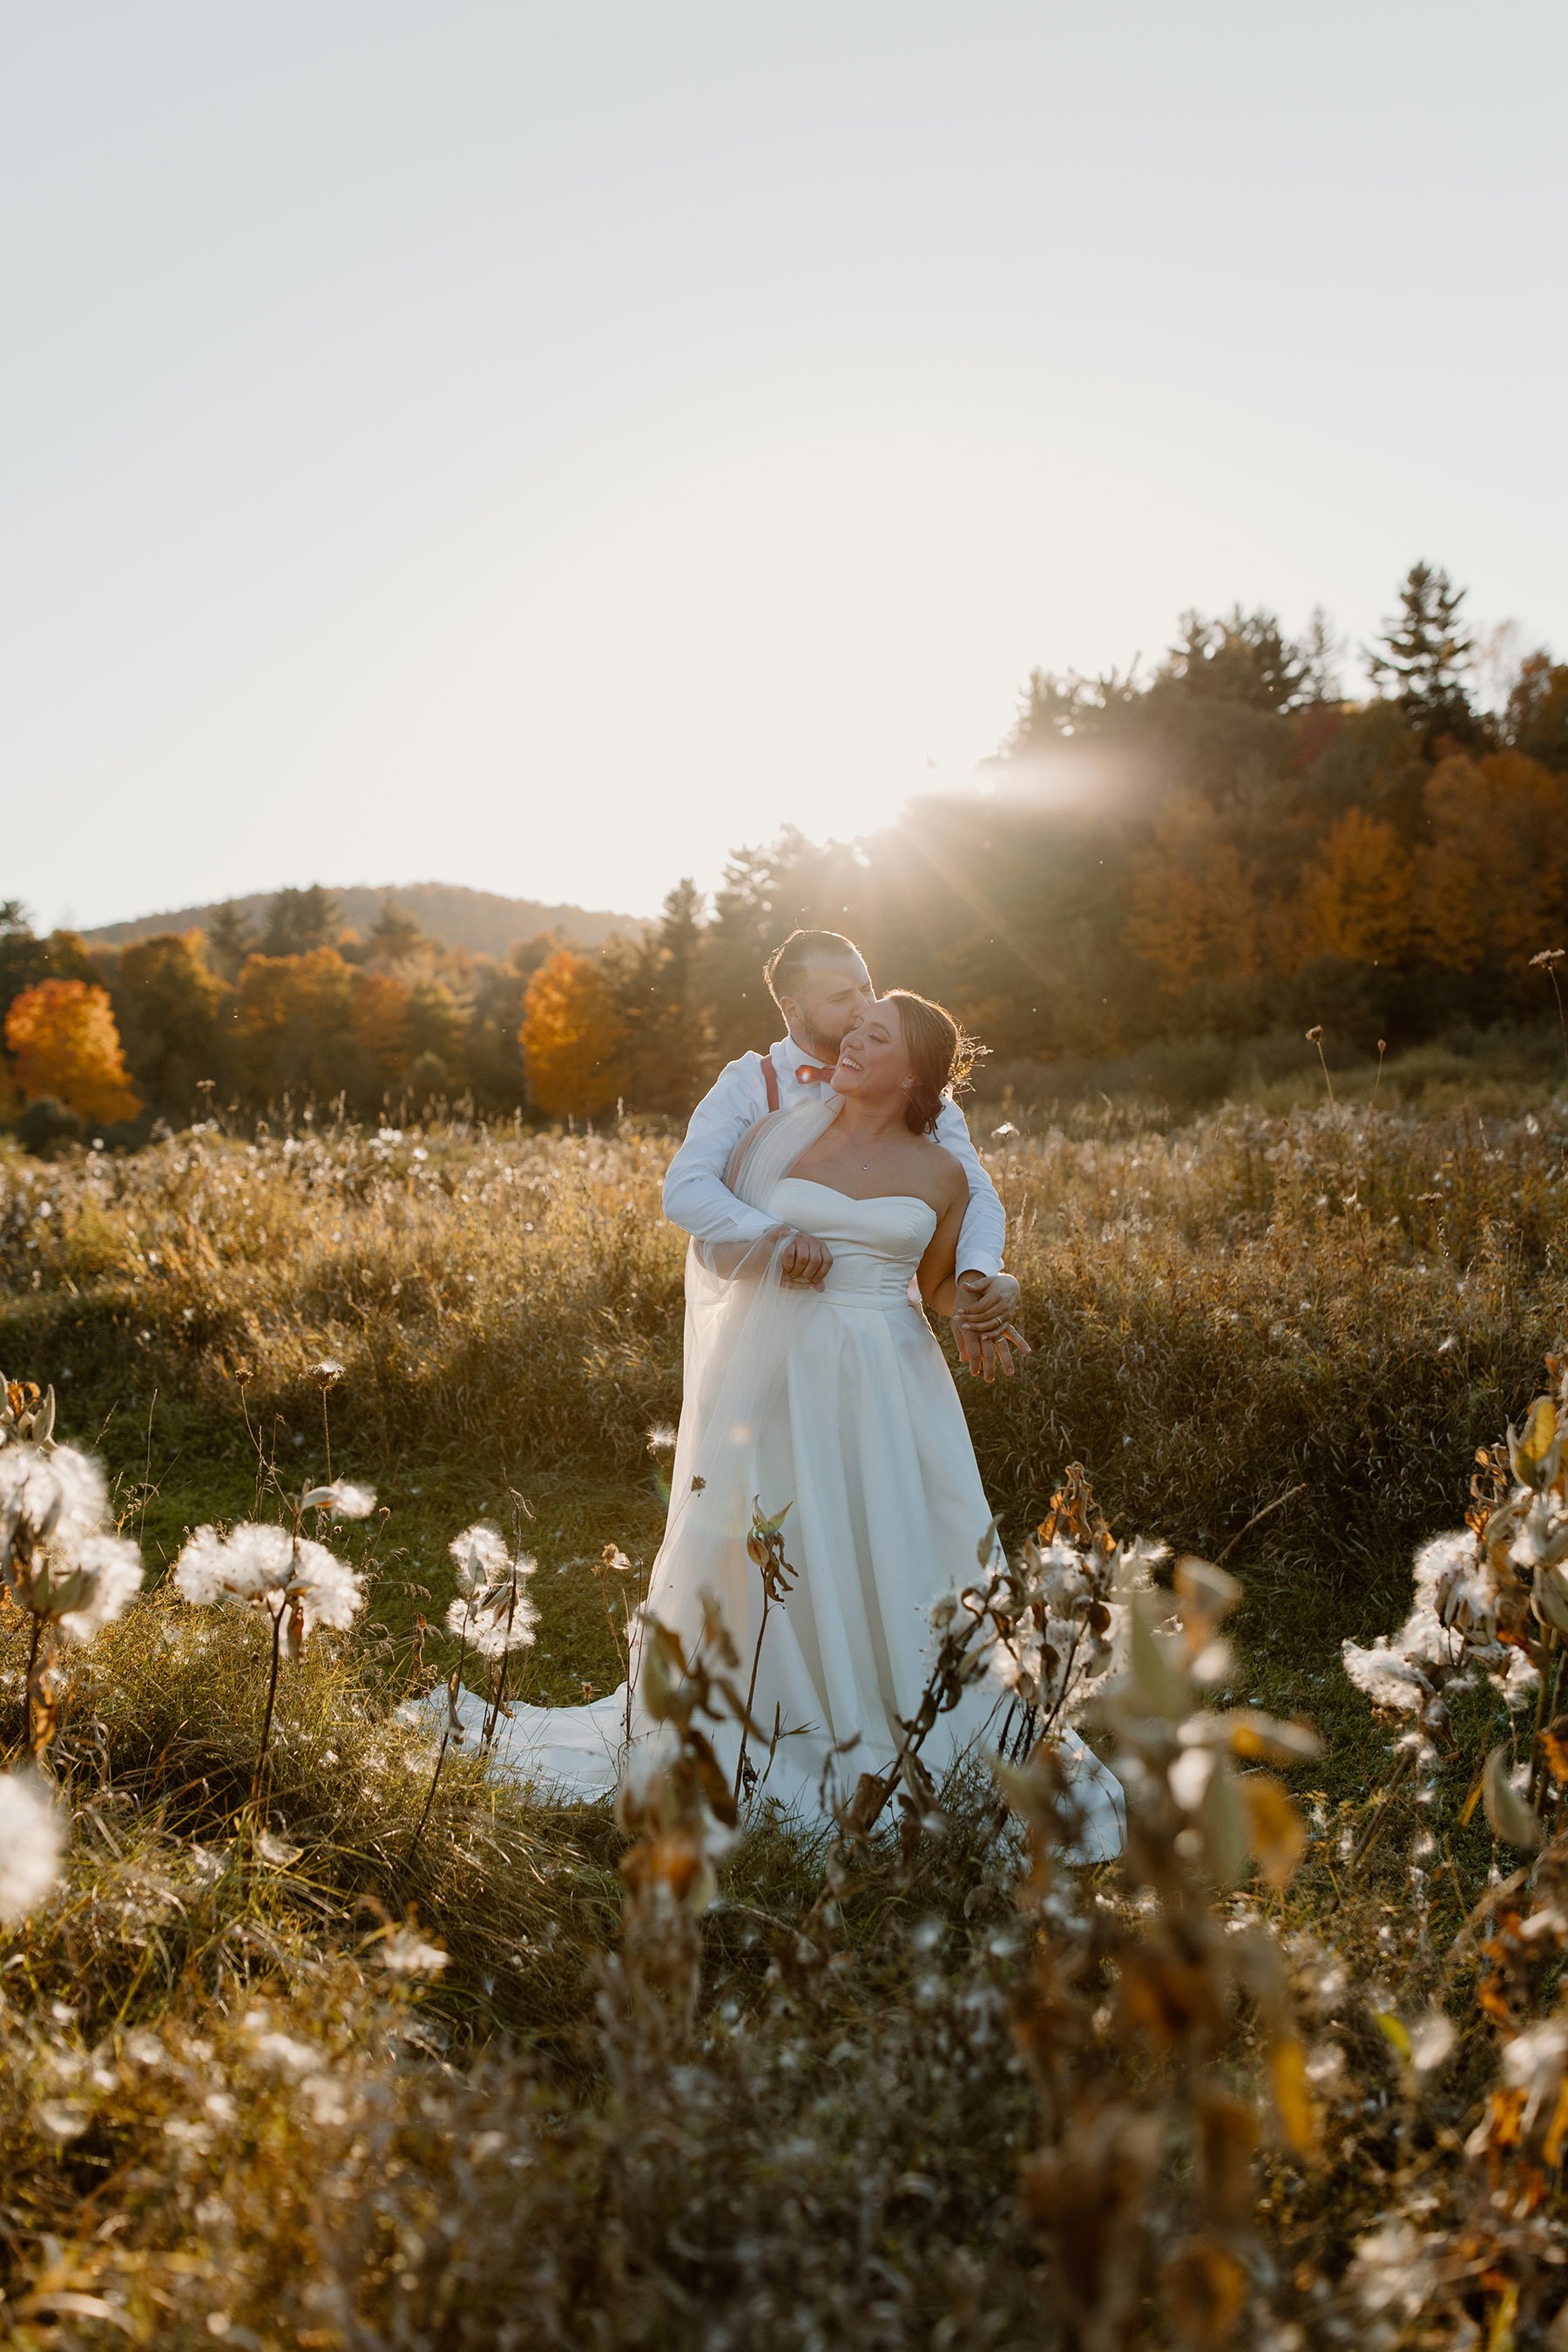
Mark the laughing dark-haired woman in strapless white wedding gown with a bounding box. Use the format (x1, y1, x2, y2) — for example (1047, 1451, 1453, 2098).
(446, 988, 1121, 1861)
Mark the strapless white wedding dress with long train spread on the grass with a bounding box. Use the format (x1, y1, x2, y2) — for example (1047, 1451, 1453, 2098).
(437, 1112, 1124, 1861)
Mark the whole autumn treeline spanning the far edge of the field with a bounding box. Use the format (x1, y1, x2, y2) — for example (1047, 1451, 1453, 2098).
(0, 564, 1568, 1132)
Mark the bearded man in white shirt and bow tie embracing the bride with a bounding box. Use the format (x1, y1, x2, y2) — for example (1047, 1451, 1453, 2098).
(666, 931, 1030, 1381)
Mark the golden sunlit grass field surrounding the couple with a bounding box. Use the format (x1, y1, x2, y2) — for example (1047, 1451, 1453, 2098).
(0, 1089, 1568, 2352)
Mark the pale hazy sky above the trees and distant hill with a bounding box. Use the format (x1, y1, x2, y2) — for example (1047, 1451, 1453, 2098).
(0, 0, 1568, 924)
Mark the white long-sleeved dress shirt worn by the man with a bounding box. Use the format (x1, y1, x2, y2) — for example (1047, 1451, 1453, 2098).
(666, 1037, 1006, 1274)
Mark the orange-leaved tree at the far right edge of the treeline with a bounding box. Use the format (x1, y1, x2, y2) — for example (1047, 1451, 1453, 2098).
(1416, 750, 1568, 995)
